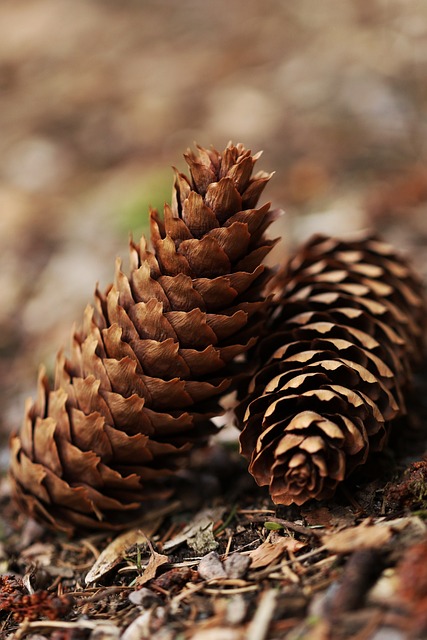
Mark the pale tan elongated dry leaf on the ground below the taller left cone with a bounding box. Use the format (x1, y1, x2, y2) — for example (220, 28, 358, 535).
(85, 518, 162, 584)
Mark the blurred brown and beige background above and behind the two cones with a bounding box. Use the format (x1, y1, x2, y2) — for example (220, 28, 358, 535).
(0, 0, 427, 467)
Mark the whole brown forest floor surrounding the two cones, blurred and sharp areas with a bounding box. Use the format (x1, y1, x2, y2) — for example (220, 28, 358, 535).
(0, 0, 427, 640)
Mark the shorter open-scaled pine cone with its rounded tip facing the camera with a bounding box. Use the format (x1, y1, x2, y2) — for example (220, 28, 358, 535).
(238, 236, 425, 505)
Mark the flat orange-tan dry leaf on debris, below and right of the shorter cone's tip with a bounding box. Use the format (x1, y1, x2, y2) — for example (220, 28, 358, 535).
(322, 523, 392, 553)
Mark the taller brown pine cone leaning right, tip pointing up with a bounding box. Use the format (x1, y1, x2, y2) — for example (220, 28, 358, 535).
(11, 144, 274, 533)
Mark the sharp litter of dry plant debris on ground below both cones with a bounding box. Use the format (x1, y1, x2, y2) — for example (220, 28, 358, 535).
(0, 444, 427, 640)
